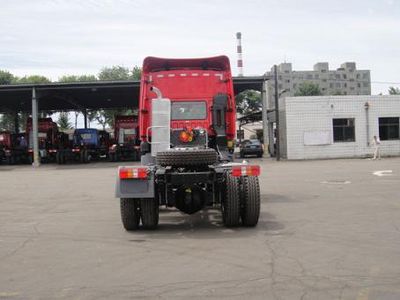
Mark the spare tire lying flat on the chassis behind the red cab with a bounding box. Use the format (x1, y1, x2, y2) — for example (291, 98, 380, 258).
(156, 148, 217, 167)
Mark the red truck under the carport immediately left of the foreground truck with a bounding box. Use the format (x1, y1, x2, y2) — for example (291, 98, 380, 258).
(109, 116, 140, 161)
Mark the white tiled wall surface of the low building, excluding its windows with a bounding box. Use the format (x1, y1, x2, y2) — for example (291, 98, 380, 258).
(281, 96, 400, 159)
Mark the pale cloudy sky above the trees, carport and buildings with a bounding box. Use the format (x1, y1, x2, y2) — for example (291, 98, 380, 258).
(0, 0, 400, 94)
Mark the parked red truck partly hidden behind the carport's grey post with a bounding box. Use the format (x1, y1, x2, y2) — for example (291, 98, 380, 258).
(26, 118, 66, 162)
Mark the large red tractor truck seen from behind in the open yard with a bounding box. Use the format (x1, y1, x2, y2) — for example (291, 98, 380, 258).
(116, 56, 260, 230)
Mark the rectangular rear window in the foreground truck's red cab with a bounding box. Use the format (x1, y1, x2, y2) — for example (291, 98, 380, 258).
(171, 101, 207, 120)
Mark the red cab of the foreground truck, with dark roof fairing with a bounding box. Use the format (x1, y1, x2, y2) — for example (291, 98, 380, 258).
(139, 56, 236, 155)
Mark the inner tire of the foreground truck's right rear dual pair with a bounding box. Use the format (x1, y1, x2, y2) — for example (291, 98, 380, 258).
(222, 173, 240, 227)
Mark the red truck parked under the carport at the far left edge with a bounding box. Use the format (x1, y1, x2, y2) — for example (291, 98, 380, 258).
(0, 131, 28, 165)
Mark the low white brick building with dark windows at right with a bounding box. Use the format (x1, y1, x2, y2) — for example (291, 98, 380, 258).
(279, 96, 400, 159)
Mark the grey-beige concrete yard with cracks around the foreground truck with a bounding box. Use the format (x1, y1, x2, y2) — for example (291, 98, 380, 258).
(0, 158, 400, 300)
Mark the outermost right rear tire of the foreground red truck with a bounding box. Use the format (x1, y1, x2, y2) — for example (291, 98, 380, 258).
(241, 177, 260, 227)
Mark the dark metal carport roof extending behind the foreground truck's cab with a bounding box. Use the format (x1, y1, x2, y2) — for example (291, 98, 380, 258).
(0, 76, 266, 112)
